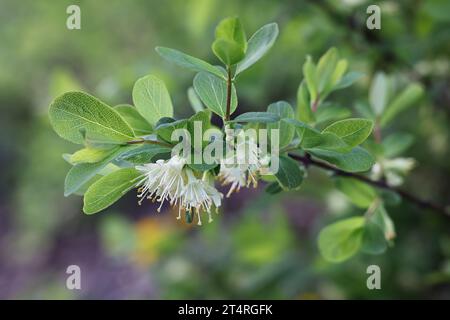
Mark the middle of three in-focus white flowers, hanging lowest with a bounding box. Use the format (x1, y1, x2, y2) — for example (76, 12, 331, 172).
(181, 169, 223, 225)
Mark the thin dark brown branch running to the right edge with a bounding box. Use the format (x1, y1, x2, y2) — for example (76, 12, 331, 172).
(289, 154, 450, 216)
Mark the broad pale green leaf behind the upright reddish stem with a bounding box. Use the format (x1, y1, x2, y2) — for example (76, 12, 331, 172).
(194, 72, 237, 118)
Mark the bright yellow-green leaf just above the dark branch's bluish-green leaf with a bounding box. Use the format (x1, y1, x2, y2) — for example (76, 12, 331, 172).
(322, 118, 373, 147)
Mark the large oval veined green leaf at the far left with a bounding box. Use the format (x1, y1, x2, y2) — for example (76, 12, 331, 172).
(49, 92, 134, 144)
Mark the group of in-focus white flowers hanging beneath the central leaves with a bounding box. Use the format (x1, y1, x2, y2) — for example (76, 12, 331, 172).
(136, 135, 267, 225)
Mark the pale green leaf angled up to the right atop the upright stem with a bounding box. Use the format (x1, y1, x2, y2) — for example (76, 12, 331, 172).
(236, 23, 278, 75)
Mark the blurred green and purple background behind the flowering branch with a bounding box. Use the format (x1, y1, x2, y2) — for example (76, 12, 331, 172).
(0, 0, 450, 299)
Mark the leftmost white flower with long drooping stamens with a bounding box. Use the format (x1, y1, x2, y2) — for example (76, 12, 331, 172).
(136, 156, 186, 212)
